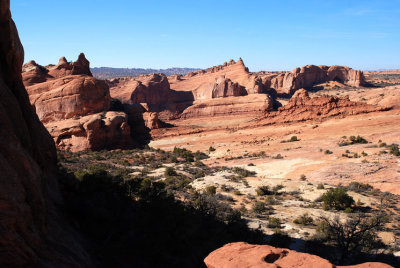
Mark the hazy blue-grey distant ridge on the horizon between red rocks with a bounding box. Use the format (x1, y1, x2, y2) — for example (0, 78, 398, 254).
(90, 67, 200, 79)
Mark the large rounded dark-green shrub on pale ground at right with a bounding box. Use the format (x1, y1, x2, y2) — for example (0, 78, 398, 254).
(322, 187, 354, 210)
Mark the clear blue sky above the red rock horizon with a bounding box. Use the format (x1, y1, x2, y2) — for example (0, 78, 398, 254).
(11, 0, 400, 71)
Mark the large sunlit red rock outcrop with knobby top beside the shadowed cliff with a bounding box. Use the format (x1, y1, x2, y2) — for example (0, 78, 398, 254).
(22, 53, 137, 151)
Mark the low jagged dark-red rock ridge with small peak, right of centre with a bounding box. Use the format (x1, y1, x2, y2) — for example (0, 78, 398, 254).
(264, 89, 387, 123)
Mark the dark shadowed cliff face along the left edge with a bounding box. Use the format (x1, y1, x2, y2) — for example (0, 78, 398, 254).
(0, 1, 95, 267)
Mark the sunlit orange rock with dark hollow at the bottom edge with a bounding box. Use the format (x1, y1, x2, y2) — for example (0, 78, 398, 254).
(204, 242, 392, 268)
